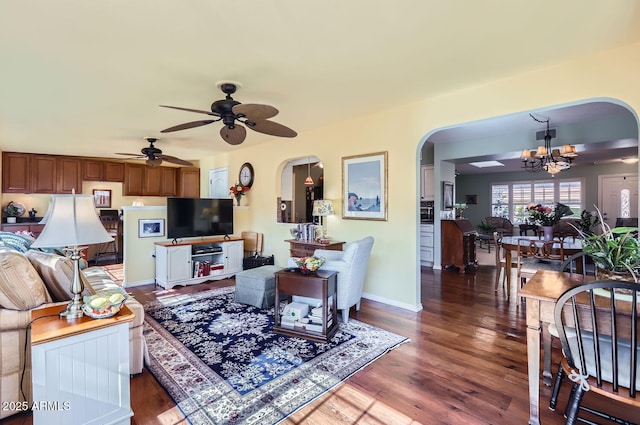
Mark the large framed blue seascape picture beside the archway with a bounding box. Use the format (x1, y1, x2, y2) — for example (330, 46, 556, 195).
(342, 152, 387, 221)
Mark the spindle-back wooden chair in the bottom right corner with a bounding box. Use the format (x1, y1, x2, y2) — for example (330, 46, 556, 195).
(549, 280, 640, 425)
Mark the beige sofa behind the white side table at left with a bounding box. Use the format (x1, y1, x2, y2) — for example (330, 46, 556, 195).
(0, 245, 146, 419)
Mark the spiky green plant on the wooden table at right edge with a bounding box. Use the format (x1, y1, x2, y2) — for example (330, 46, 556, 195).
(574, 208, 640, 282)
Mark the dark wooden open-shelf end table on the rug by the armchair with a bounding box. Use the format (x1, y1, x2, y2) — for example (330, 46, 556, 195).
(273, 269, 338, 342)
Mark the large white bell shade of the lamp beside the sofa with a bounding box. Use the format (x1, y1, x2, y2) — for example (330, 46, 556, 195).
(31, 195, 113, 248)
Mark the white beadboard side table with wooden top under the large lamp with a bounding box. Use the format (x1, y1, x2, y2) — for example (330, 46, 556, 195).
(31, 306, 134, 425)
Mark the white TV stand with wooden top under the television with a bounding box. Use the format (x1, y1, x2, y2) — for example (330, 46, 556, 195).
(155, 237, 244, 289)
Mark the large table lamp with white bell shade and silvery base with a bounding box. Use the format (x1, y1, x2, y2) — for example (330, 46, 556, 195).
(31, 194, 113, 319)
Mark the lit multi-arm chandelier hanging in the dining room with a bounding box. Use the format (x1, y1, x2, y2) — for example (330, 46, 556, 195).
(520, 114, 578, 174)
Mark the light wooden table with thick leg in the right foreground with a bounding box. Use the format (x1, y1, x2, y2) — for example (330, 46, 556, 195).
(518, 270, 584, 425)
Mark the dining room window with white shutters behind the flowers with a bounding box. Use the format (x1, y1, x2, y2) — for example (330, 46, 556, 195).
(491, 179, 583, 224)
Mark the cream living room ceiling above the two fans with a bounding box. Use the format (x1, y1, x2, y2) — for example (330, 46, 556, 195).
(0, 0, 640, 160)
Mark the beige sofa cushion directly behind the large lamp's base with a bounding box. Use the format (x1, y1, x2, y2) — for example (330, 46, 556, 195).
(25, 249, 86, 302)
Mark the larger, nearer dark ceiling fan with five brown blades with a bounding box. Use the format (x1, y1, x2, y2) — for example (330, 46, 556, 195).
(160, 82, 298, 145)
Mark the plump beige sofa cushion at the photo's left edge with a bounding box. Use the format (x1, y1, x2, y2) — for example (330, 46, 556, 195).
(0, 248, 50, 310)
